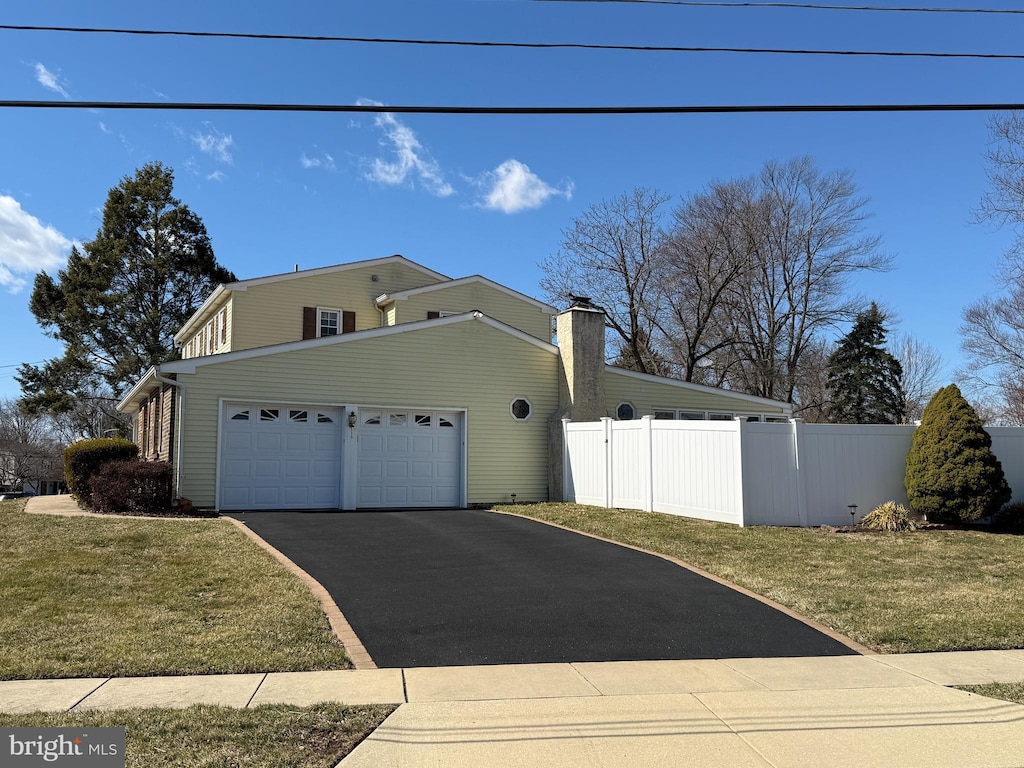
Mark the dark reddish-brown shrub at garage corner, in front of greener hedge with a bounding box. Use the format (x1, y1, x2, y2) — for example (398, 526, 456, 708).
(91, 459, 171, 515)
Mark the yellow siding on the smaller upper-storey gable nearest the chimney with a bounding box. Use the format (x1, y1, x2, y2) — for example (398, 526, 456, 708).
(389, 283, 551, 342)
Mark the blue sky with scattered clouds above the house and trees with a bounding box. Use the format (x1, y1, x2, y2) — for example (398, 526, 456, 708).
(0, 0, 1024, 397)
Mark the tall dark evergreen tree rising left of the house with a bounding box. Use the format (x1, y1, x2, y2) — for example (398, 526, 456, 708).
(16, 163, 236, 414)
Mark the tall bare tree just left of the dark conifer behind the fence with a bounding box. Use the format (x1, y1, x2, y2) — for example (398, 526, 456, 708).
(732, 157, 890, 402)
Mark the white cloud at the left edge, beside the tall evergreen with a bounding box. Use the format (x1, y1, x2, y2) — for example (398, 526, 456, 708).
(0, 195, 72, 293)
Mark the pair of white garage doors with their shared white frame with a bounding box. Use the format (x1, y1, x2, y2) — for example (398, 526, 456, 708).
(217, 402, 464, 510)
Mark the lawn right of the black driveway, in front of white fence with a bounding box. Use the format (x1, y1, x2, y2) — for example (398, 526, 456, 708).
(497, 504, 1024, 653)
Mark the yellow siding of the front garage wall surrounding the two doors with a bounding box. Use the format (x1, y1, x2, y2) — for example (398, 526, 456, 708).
(178, 322, 558, 507)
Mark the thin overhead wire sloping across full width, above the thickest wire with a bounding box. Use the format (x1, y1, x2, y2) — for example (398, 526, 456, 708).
(0, 24, 1024, 59)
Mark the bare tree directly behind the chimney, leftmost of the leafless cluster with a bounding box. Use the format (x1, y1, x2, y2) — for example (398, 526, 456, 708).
(540, 187, 669, 374)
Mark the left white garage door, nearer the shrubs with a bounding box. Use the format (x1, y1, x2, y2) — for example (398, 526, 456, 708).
(219, 403, 342, 509)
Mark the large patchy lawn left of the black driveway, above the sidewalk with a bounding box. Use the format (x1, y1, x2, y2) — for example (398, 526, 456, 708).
(0, 500, 351, 680)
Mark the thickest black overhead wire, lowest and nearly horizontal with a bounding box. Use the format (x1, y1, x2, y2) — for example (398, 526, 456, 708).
(6, 100, 1024, 115)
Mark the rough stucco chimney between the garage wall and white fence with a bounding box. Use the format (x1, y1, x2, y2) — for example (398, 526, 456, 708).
(548, 296, 605, 501)
